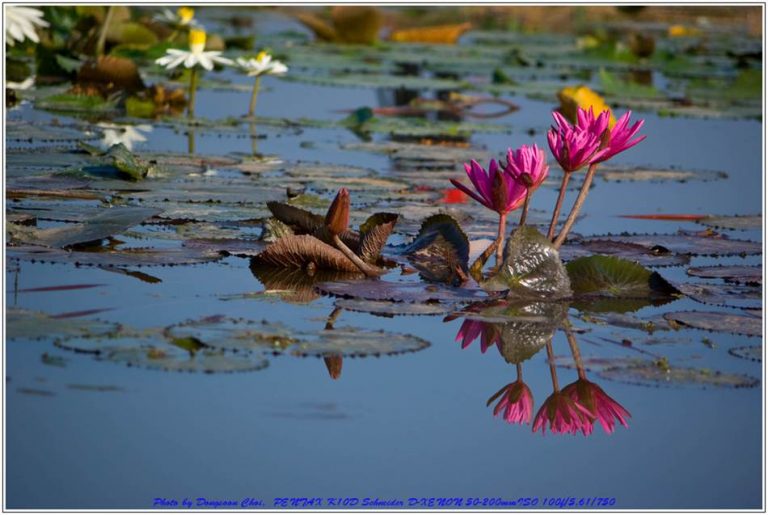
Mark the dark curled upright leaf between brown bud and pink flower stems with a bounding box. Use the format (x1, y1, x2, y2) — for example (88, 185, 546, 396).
(403, 214, 469, 285)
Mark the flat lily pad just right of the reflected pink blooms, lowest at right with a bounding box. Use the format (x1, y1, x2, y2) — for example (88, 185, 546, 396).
(597, 362, 760, 388)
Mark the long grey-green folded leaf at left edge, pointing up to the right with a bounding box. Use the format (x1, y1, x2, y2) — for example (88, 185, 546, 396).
(8, 207, 160, 248)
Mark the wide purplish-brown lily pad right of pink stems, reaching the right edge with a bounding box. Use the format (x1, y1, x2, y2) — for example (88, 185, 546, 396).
(584, 231, 763, 256)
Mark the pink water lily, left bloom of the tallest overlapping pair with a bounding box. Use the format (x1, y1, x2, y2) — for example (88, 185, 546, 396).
(547, 108, 610, 173)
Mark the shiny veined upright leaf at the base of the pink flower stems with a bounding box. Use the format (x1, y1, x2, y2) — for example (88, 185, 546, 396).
(482, 226, 571, 300)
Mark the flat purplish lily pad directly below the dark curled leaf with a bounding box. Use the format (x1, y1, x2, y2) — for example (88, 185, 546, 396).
(317, 281, 487, 303)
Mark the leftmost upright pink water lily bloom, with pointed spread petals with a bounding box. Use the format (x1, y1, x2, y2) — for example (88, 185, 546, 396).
(451, 159, 526, 215)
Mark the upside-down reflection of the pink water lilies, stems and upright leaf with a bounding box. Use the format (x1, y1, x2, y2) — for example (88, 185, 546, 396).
(448, 301, 630, 436)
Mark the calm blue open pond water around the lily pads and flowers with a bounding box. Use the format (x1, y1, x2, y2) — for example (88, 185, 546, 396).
(5, 9, 763, 509)
